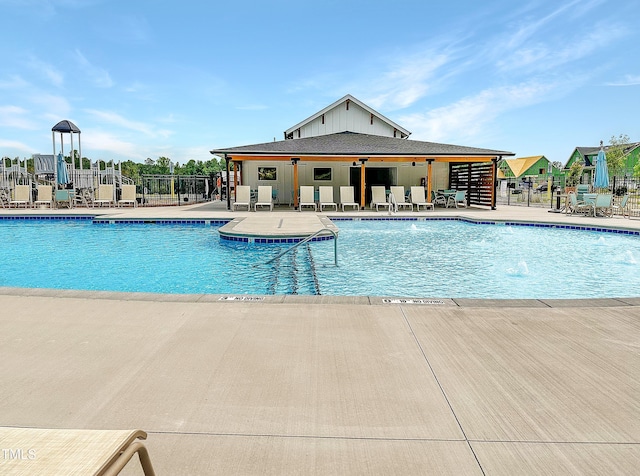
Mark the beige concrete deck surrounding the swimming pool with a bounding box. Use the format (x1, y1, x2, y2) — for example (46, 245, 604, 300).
(0, 204, 640, 475)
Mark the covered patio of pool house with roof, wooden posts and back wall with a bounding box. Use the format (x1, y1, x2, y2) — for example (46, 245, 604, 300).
(211, 132, 514, 209)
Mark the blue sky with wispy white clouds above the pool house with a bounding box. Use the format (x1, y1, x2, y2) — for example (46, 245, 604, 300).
(0, 0, 640, 167)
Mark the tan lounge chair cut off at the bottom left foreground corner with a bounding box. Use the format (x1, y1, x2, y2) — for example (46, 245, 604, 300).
(0, 427, 155, 476)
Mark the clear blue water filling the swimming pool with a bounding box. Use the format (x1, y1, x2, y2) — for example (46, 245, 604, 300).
(0, 220, 640, 298)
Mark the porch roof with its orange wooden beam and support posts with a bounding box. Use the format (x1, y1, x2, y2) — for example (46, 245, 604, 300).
(211, 132, 514, 209)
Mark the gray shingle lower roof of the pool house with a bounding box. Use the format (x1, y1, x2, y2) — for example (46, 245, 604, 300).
(211, 132, 515, 157)
